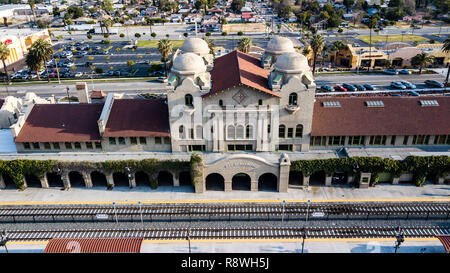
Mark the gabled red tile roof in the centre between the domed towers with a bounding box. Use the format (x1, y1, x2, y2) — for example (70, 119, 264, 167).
(203, 50, 281, 97)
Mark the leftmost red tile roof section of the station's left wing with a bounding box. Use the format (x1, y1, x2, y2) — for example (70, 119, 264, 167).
(14, 103, 103, 142)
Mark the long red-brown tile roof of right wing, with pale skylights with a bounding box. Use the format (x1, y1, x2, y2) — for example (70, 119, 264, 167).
(311, 96, 450, 136)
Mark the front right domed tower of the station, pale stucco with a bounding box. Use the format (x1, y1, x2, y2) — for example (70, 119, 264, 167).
(269, 52, 316, 151)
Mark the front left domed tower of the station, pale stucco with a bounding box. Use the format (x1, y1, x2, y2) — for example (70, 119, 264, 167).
(167, 52, 211, 152)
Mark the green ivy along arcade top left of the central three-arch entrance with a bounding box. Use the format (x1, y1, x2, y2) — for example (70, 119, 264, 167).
(0, 159, 189, 189)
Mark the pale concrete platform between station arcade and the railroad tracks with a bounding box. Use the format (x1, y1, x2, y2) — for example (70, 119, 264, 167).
(0, 183, 450, 205)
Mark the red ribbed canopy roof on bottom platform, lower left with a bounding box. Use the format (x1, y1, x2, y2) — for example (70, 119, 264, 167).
(44, 238, 143, 253)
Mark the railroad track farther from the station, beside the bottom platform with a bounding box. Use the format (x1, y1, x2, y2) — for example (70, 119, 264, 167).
(3, 226, 450, 241)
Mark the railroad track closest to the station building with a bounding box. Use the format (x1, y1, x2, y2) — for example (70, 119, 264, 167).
(0, 202, 450, 222)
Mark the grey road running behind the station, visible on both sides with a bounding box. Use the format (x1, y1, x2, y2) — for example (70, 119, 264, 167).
(0, 74, 445, 97)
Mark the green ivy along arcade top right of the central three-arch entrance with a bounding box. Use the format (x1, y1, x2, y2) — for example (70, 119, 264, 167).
(291, 156, 450, 186)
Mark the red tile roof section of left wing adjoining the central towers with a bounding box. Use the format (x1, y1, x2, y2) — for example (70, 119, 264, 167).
(103, 99, 170, 137)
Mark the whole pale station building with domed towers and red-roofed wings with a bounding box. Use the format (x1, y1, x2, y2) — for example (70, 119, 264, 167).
(3, 37, 450, 192)
